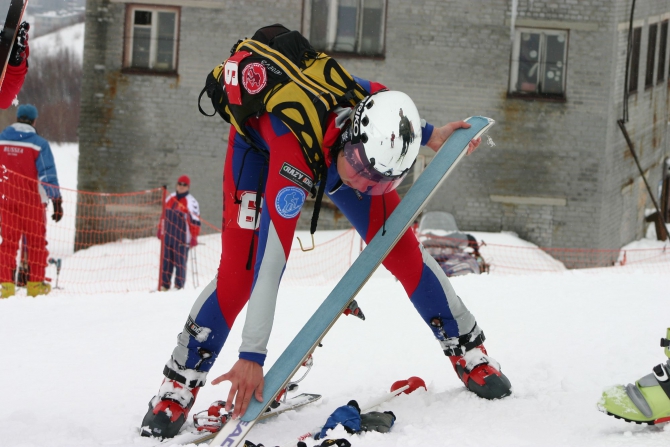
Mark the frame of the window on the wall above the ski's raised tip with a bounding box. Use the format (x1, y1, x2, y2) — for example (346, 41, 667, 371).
(507, 26, 570, 102)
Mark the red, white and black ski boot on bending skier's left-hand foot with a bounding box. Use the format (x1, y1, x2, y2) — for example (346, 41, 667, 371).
(140, 378, 200, 438)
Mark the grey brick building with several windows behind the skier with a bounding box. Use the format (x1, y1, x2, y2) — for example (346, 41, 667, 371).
(79, 0, 670, 266)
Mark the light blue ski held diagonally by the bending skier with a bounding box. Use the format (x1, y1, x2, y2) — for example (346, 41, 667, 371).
(210, 116, 494, 447)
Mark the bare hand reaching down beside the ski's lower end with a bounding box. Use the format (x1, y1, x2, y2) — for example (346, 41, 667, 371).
(212, 359, 265, 419)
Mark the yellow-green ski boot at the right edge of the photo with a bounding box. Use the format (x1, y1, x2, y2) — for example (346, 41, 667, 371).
(598, 328, 670, 425)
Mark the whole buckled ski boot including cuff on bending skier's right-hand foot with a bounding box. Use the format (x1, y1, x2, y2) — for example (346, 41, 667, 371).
(430, 317, 512, 399)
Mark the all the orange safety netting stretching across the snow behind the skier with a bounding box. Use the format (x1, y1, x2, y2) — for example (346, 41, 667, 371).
(0, 167, 670, 293)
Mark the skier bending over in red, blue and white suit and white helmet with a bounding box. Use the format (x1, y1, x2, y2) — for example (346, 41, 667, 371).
(142, 25, 511, 437)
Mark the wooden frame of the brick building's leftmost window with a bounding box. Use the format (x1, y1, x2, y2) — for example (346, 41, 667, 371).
(122, 3, 181, 76)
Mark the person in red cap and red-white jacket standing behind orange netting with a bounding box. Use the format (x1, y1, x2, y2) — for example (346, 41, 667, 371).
(158, 175, 200, 291)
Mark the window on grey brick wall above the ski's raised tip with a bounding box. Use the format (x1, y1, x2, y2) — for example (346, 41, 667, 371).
(509, 28, 568, 98)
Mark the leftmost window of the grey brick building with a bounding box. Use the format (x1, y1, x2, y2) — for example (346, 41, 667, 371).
(124, 5, 179, 73)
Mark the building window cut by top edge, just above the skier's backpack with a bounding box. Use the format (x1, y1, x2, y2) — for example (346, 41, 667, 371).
(303, 0, 386, 56)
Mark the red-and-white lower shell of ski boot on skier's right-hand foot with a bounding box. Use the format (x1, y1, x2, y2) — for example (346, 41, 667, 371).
(449, 345, 512, 399)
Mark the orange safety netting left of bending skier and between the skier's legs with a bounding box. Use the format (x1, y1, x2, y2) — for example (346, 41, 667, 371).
(0, 167, 358, 293)
